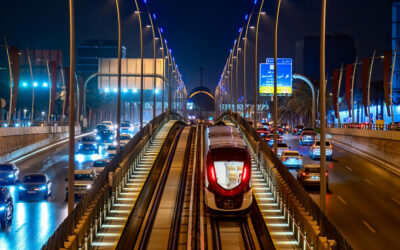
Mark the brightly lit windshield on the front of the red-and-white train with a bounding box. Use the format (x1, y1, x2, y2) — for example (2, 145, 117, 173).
(214, 161, 244, 190)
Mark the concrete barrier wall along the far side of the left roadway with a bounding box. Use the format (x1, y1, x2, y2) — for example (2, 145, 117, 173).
(0, 127, 81, 158)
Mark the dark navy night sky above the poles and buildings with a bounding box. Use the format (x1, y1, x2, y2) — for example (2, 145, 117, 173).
(0, 0, 391, 93)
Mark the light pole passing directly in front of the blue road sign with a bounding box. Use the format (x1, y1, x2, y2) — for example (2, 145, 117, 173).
(274, 0, 282, 154)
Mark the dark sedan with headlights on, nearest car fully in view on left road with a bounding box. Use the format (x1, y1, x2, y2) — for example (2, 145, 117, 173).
(18, 173, 52, 200)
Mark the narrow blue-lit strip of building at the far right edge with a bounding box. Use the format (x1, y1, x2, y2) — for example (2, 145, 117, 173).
(392, 0, 400, 104)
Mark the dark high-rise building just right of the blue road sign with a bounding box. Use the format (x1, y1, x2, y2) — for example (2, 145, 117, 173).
(295, 32, 356, 82)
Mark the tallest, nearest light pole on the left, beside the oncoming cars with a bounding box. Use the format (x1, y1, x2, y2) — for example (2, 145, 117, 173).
(68, 0, 75, 215)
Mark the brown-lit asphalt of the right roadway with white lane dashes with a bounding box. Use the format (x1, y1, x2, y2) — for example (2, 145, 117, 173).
(283, 135, 400, 249)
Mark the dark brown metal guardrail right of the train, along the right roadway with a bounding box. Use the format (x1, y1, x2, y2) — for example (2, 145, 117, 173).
(222, 113, 352, 250)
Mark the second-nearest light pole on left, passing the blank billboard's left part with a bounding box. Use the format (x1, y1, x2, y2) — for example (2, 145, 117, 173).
(115, 0, 122, 154)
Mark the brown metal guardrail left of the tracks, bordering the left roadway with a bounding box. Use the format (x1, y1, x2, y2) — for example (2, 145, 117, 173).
(42, 114, 170, 250)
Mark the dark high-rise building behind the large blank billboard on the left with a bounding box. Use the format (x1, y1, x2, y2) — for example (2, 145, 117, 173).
(76, 40, 126, 79)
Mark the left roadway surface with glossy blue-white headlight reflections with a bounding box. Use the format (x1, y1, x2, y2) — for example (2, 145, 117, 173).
(0, 133, 109, 250)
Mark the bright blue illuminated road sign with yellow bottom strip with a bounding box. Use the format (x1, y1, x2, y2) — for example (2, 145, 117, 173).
(259, 58, 293, 96)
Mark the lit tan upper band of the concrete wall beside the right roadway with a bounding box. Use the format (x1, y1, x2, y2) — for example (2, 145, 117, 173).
(327, 128, 400, 141)
